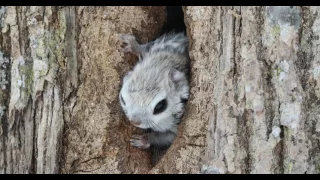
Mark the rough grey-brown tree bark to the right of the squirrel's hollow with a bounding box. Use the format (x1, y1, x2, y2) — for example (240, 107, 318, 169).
(153, 7, 320, 173)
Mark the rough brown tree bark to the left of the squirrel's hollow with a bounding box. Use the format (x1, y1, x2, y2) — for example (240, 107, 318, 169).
(0, 7, 166, 173)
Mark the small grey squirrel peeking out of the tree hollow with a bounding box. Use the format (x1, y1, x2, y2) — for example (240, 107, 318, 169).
(119, 32, 190, 149)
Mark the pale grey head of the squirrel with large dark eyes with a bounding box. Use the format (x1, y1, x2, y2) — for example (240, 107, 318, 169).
(119, 63, 189, 132)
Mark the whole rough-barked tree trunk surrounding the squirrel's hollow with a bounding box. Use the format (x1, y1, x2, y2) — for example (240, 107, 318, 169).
(0, 6, 320, 173)
